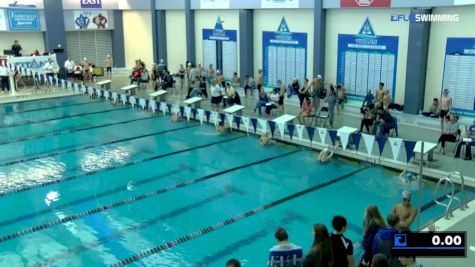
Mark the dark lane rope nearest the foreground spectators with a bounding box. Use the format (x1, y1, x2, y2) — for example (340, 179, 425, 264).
(109, 166, 369, 267)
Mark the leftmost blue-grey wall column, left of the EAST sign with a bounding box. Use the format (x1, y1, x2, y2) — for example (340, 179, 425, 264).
(44, 0, 68, 66)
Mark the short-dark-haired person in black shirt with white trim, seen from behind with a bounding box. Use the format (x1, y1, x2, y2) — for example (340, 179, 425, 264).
(330, 216, 355, 267)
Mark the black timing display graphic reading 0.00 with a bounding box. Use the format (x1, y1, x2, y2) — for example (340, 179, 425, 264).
(392, 232, 467, 257)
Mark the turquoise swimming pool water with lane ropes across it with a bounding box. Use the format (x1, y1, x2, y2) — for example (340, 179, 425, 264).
(0, 96, 475, 266)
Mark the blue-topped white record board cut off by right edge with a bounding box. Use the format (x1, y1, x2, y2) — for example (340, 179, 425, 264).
(441, 38, 475, 116)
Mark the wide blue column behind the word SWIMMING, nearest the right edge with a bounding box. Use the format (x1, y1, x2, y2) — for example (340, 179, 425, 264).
(404, 9, 432, 114)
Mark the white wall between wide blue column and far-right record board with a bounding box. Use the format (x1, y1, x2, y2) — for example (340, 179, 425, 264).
(424, 5, 475, 108)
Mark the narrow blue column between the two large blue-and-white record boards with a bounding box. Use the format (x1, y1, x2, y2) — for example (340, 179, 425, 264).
(309, 0, 327, 80)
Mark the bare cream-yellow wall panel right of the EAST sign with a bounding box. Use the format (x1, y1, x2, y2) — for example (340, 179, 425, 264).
(123, 10, 153, 68)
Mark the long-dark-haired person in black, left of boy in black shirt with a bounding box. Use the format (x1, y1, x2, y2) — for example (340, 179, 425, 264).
(302, 224, 333, 267)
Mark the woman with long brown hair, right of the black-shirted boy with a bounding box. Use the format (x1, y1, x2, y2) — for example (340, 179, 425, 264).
(360, 205, 386, 266)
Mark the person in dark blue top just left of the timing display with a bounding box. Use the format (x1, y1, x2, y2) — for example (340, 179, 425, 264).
(373, 216, 399, 266)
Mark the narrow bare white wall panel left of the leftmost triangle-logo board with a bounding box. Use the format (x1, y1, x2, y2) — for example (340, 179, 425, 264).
(165, 10, 186, 73)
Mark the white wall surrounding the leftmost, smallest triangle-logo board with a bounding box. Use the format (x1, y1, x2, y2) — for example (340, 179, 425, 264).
(195, 10, 239, 73)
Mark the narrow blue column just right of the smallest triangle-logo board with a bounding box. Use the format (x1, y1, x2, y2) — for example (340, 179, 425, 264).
(239, 9, 254, 85)
